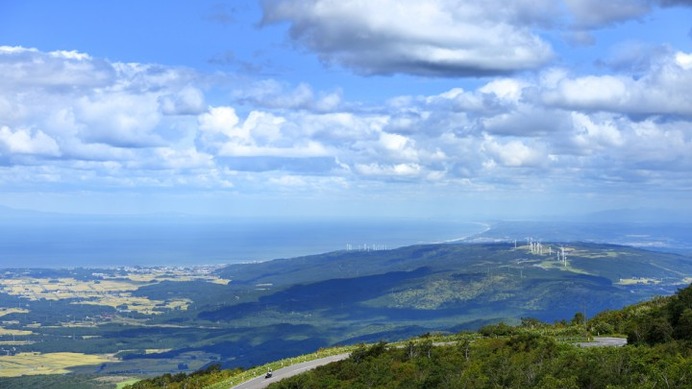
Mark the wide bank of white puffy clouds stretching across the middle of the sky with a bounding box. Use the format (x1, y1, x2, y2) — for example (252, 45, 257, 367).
(0, 42, 692, 199)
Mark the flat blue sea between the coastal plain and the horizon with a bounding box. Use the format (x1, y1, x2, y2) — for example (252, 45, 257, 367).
(0, 217, 487, 268)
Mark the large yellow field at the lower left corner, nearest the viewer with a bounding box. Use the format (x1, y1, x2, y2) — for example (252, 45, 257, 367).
(0, 353, 117, 377)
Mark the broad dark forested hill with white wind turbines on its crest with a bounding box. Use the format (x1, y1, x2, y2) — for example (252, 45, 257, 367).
(198, 243, 692, 354)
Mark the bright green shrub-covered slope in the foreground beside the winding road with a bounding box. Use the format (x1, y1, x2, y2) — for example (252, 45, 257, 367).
(125, 285, 692, 389)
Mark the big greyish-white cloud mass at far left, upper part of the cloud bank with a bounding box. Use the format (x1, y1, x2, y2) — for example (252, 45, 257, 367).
(0, 46, 206, 159)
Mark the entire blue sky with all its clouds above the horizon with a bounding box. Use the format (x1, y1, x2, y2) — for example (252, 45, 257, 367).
(0, 0, 692, 219)
